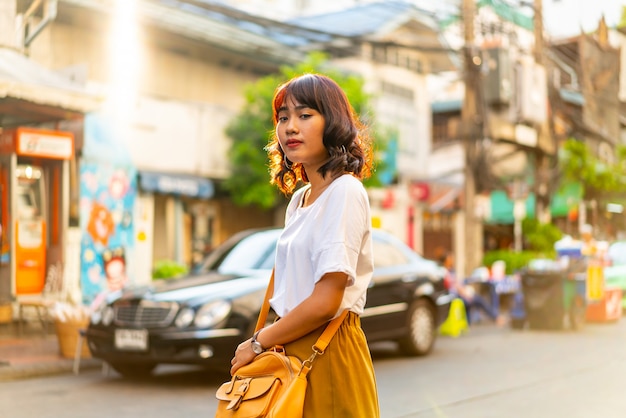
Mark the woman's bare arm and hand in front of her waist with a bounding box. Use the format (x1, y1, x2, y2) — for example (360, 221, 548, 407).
(230, 273, 348, 374)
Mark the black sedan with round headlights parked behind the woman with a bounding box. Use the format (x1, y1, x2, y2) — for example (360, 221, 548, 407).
(86, 229, 451, 377)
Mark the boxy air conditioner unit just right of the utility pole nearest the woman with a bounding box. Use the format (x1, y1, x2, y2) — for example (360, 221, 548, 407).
(483, 48, 513, 105)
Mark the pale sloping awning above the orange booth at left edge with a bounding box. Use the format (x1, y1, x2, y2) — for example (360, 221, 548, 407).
(0, 47, 103, 127)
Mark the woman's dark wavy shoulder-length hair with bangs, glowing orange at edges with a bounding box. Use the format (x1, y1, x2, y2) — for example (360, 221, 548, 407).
(266, 74, 373, 195)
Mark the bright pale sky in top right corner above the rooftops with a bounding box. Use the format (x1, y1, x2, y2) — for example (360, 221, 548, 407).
(543, 0, 626, 38)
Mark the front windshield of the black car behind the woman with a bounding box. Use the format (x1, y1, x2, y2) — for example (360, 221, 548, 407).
(198, 230, 280, 274)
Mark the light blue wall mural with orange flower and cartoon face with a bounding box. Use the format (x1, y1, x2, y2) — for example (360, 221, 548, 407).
(80, 115, 137, 304)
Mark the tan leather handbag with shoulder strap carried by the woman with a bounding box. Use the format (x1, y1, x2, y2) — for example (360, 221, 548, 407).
(215, 271, 348, 418)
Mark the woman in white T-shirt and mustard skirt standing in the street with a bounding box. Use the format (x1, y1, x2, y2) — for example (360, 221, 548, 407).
(231, 74, 379, 418)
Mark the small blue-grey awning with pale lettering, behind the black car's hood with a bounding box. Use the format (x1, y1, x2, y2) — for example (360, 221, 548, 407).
(139, 171, 215, 199)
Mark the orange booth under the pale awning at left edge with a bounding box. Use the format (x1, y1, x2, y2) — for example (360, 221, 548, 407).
(0, 127, 74, 295)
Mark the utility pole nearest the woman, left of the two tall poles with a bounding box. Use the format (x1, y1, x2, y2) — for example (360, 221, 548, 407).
(458, 0, 486, 277)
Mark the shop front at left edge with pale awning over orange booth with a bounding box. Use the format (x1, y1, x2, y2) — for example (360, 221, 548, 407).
(0, 48, 101, 319)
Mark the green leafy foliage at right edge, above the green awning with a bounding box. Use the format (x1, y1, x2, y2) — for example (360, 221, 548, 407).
(559, 139, 626, 199)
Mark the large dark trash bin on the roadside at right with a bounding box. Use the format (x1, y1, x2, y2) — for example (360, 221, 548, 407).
(522, 271, 586, 330)
